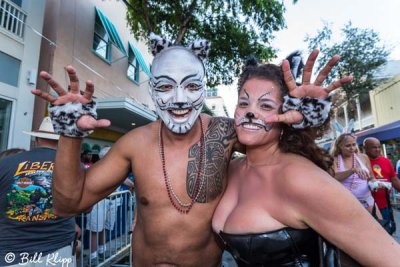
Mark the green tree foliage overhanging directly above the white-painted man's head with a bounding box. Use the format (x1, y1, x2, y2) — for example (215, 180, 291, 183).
(127, 0, 297, 86)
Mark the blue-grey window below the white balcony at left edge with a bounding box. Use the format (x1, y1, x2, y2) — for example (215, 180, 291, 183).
(0, 51, 21, 87)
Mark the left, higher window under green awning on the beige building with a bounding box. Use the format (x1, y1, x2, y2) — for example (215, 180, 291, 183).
(93, 14, 111, 62)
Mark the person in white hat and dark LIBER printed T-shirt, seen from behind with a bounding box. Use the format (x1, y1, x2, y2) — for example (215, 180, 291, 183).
(0, 117, 76, 267)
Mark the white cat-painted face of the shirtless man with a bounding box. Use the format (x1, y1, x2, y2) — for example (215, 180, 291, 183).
(150, 46, 205, 134)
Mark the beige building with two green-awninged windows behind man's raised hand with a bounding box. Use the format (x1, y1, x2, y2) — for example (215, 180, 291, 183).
(33, 0, 157, 150)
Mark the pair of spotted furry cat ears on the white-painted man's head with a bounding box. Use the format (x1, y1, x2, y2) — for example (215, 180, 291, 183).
(150, 33, 211, 61)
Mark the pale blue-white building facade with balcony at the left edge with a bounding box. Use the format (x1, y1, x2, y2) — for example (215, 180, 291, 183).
(0, 0, 46, 151)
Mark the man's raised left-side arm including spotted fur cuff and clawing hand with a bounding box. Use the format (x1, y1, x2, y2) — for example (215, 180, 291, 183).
(32, 66, 130, 216)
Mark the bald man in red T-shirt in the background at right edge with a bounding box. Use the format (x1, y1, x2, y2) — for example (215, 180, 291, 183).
(363, 137, 400, 221)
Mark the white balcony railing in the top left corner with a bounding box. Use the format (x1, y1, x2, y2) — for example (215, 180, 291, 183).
(0, 0, 27, 39)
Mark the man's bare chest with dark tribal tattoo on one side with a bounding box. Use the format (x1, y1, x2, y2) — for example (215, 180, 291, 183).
(133, 118, 236, 203)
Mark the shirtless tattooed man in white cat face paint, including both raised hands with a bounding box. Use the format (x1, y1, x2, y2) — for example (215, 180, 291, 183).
(32, 33, 348, 267)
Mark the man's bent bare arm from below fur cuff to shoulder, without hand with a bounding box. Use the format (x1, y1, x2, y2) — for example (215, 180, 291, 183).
(53, 136, 133, 216)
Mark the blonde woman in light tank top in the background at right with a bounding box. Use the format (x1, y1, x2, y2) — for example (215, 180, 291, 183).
(331, 133, 382, 218)
